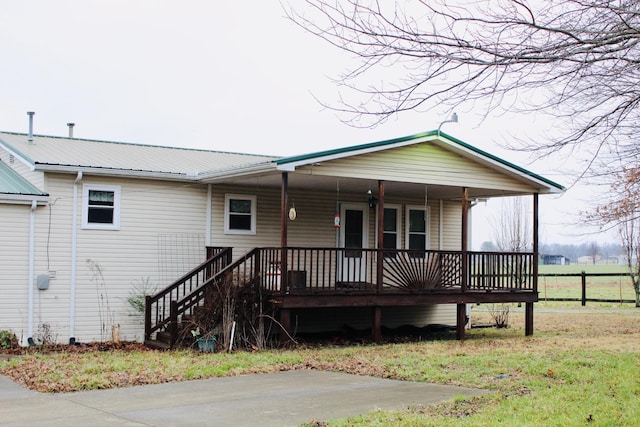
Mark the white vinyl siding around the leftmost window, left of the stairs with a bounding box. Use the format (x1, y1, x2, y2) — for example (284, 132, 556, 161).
(28, 174, 207, 342)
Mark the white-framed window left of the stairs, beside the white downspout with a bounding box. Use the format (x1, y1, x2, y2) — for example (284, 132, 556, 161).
(82, 184, 120, 230)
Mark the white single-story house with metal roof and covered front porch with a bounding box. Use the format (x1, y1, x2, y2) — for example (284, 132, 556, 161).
(0, 125, 563, 344)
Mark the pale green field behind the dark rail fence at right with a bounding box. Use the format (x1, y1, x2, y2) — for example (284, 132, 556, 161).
(538, 264, 635, 305)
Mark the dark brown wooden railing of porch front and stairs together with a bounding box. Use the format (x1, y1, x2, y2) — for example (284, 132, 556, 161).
(145, 247, 537, 346)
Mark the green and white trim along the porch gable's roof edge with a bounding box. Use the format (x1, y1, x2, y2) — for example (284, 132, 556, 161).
(276, 130, 565, 191)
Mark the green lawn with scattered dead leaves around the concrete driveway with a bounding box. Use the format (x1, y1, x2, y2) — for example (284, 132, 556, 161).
(0, 309, 640, 426)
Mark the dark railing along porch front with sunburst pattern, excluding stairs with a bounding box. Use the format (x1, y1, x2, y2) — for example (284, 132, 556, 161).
(259, 248, 537, 293)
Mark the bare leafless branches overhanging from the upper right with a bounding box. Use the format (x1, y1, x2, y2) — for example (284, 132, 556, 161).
(286, 0, 640, 170)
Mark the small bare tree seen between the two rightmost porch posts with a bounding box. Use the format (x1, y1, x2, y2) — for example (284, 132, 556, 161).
(491, 197, 533, 252)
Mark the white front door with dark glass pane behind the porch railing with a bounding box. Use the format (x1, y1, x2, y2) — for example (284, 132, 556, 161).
(338, 204, 369, 284)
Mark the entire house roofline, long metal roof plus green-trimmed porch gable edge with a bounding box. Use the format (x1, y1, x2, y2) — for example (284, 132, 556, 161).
(0, 131, 564, 193)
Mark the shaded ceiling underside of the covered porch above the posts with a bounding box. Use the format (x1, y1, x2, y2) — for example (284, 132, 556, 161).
(209, 172, 530, 200)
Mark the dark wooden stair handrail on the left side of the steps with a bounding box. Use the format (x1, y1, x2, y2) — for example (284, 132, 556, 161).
(144, 247, 232, 340)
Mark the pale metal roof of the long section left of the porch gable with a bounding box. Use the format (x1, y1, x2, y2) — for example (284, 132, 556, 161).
(0, 132, 277, 179)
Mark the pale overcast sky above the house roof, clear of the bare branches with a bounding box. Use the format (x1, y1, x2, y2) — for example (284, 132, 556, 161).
(0, 0, 611, 245)
